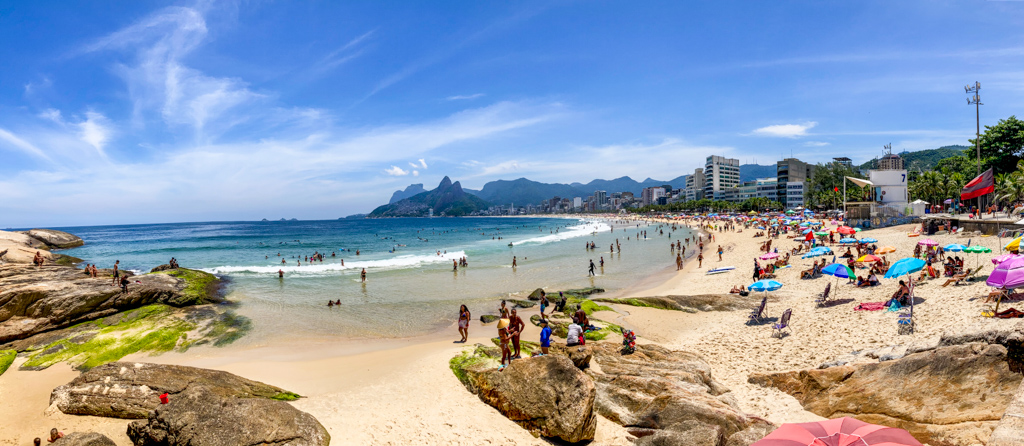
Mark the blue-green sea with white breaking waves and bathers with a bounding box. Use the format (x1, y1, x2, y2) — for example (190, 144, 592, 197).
(61, 218, 691, 343)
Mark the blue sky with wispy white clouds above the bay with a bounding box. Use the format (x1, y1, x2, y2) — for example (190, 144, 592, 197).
(0, 1, 1024, 223)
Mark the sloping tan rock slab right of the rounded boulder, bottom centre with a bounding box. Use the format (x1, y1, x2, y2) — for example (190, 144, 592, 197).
(588, 343, 774, 446)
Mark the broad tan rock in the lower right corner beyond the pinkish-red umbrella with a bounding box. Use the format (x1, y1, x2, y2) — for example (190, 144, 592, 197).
(749, 343, 1022, 446)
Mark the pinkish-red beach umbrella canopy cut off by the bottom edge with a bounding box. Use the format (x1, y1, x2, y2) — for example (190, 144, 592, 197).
(751, 417, 922, 446)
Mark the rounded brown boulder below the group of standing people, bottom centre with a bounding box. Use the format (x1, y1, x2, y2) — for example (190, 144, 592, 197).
(453, 355, 597, 443)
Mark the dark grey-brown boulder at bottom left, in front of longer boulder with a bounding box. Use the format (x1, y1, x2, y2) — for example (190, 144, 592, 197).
(128, 386, 331, 446)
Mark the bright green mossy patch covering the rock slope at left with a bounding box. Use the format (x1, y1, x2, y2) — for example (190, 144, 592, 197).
(22, 304, 249, 370)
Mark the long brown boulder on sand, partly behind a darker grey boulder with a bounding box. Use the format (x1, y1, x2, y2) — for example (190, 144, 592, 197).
(50, 362, 298, 418)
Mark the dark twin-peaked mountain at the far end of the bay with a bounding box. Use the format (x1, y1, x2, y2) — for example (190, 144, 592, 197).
(368, 177, 489, 218)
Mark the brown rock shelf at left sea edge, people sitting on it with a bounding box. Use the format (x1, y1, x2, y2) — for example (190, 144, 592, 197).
(0, 265, 217, 344)
